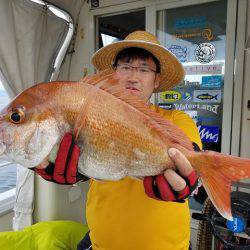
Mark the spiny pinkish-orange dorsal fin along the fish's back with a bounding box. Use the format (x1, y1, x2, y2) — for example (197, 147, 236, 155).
(81, 70, 193, 150)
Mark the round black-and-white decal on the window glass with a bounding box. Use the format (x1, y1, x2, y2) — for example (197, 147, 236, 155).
(194, 43, 215, 63)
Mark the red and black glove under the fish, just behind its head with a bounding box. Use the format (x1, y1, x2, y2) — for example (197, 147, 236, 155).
(33, 133, 87, 185)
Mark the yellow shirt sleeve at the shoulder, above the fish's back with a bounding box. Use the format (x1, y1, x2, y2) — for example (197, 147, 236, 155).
(173, 110, 202, 149)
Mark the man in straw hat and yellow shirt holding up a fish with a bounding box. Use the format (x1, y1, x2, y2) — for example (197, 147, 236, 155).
(34, 31, 201, 250)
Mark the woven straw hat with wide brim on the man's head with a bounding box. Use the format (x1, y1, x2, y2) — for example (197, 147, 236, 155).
(92, 31, 185, 93)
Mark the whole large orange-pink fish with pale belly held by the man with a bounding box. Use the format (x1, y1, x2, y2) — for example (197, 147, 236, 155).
(0, 71, 250, 219)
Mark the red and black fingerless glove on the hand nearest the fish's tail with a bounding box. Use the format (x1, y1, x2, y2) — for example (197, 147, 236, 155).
(143, 170, 198, 202)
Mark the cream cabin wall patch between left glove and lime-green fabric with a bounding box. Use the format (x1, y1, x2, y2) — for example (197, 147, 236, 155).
(34, 176, 88, 224)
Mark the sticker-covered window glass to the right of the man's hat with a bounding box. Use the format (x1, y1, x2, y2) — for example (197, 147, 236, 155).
(157, 1, 227, 210)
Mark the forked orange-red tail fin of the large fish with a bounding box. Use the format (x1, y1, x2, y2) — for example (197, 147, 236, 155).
(188, 151, 250, 220)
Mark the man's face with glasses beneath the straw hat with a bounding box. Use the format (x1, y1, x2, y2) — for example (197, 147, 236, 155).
(115, 58, 159, 102)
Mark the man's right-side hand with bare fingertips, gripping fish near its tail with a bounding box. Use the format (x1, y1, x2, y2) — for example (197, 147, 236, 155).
(143, 148, 198, 202)
